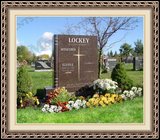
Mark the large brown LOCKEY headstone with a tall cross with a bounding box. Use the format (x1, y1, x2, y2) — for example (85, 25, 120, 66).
(54, 35, 98, 92)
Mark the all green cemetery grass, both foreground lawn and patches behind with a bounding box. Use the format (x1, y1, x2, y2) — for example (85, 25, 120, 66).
(17, 64, 143, 123)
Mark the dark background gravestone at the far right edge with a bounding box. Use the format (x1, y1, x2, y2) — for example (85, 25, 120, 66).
(133, 57, 143, 70)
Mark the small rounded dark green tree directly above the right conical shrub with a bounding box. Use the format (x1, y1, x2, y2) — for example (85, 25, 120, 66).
(119, 43, 133, 59)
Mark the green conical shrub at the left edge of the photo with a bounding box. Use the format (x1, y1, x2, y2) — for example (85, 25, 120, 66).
(17, 66, 32, 98)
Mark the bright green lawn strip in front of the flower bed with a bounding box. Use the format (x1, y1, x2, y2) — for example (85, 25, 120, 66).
(17, 97, 143, 123)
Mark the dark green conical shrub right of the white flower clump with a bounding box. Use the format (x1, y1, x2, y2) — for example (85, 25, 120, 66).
(111, 63, 133, 90)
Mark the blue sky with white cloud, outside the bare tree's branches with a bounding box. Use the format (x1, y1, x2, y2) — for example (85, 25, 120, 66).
(16, 16, 144, 55)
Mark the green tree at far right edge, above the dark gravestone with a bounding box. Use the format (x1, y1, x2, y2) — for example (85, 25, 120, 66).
(134, 40, 143, 56)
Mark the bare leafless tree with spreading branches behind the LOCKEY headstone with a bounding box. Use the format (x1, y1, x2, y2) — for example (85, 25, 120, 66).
(77, 17, 137, 77)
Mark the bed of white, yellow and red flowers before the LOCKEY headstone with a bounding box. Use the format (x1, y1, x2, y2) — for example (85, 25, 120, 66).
(42, 79, 142, 113)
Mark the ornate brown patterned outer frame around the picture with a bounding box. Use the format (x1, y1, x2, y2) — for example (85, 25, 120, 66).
(1, 1, 159, 139)
